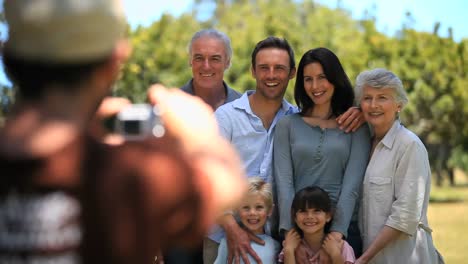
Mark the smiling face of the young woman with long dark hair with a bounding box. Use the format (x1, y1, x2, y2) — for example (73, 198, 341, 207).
(303, 62, 335, 107)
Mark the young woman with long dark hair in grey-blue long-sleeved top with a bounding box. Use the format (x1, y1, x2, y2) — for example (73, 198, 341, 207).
(273, 48, 370, 255)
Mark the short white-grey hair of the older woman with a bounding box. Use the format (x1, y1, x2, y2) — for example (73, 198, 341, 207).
(354, 68, 408, 107)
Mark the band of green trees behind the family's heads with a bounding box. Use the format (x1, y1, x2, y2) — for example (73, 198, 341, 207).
(116, 0, 468, 184)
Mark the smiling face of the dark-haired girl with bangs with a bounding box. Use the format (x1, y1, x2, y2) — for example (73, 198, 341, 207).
(294, 208, 331, 236)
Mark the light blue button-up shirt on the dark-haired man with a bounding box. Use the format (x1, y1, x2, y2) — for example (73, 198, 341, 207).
(208, 90, 298, 243)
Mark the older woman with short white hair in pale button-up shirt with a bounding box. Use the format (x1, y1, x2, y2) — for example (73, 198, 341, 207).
(356, 69, 443, 264)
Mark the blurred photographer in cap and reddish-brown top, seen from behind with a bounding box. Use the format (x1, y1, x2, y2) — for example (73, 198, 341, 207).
(0, 0, 246, 264)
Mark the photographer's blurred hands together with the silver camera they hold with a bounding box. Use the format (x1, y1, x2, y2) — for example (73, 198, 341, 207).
(96, 84, 219, 148)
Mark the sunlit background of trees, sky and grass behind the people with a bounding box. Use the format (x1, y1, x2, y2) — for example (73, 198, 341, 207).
(0, 0, 468, 264)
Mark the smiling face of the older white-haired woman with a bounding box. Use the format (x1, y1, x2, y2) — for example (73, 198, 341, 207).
(361, 86, 402, 137)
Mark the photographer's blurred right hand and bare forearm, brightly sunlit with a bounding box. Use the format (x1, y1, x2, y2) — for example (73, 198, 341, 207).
(148, 85, 247, 216)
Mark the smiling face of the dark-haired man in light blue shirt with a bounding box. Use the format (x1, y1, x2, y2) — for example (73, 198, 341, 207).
(252, 48, 296, 100)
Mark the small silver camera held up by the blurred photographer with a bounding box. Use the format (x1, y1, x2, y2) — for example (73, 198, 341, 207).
(114, 104, 165, 140)
